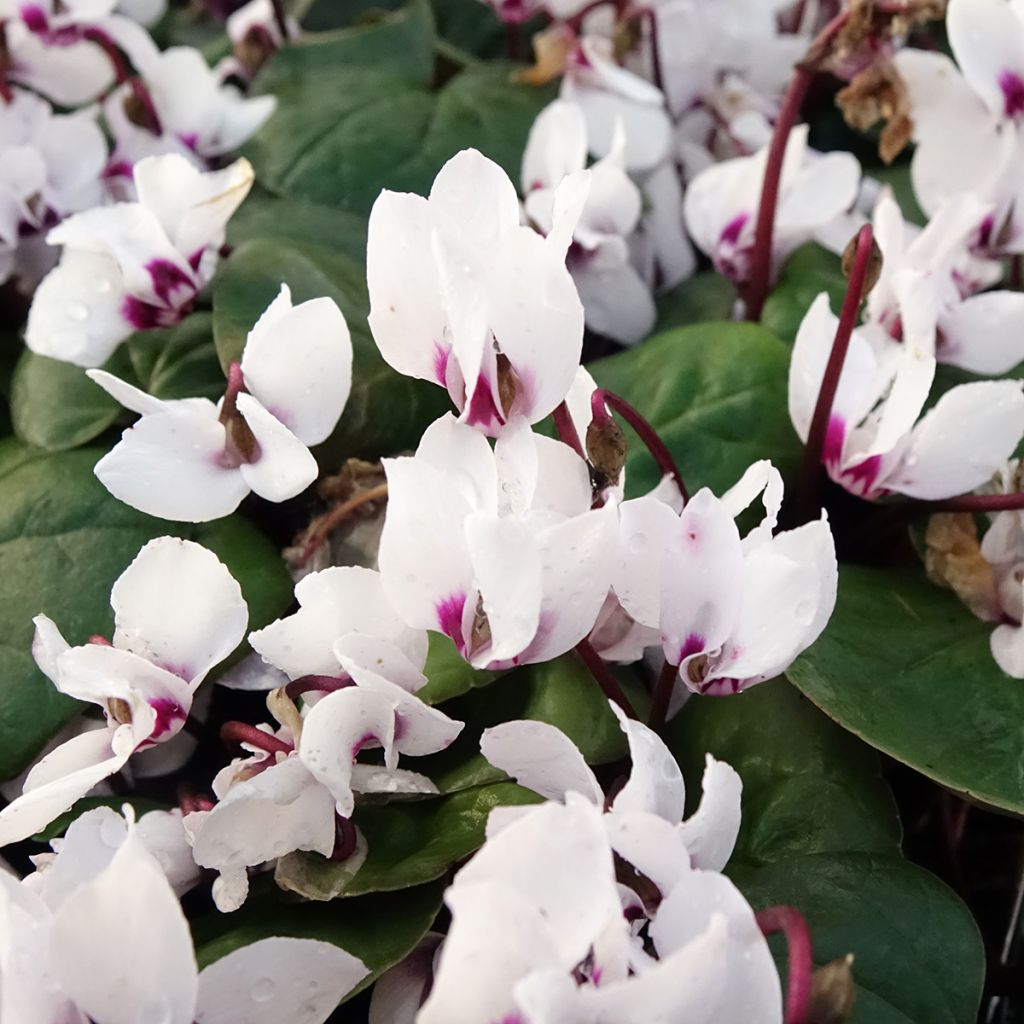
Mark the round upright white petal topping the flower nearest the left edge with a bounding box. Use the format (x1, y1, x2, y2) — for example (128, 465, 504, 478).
(111, 537, 249, 687)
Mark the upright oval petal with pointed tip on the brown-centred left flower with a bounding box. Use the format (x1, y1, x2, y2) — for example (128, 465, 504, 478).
(242, 285, 352, 444)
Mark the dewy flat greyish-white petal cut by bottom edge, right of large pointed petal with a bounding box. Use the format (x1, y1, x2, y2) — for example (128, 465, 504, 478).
(196, 938, 370, 1024)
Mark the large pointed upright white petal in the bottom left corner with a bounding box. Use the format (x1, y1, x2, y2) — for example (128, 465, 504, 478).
(53, 833, 198, 1024)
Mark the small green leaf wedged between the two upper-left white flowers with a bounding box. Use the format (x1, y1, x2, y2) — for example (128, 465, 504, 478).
(126, 312, 224, 400)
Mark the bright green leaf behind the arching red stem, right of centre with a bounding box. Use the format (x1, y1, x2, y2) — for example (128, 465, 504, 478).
(588, 323, 801, 495)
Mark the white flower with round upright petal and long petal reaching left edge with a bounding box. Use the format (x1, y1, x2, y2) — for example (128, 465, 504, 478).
(0, 537, 249, 846)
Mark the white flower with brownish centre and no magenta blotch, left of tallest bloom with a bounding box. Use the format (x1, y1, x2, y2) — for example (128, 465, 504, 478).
(89, 285, 352, 522)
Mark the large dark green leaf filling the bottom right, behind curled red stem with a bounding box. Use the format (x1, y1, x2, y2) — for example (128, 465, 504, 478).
(669, 677, 984, 1024)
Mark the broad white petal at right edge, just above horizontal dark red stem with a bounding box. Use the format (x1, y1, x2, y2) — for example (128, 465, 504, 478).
(885, 381, 1024, 500)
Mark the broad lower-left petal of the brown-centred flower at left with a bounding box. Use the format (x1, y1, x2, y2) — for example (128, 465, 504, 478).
(95, 403, 249, 522)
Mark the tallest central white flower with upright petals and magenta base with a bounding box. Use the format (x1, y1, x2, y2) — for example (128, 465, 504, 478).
(367, 150, 587, 434)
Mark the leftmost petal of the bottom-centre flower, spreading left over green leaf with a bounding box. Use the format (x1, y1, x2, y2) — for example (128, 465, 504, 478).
(480, 722, 604, 807)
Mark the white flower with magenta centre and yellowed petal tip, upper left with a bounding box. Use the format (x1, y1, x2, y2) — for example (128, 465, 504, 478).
(25, 155, 253, 367)
